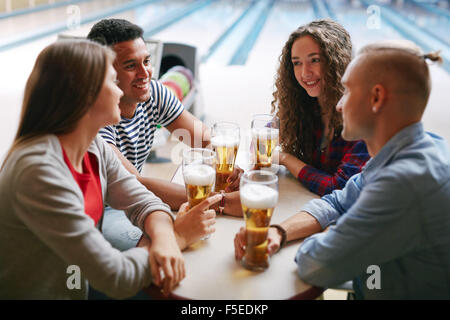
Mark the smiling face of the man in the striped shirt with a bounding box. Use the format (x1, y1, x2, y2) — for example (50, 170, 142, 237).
(113, 38, 152, 109)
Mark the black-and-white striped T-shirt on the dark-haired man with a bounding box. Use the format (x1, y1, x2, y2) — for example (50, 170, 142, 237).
(100, 80, 184, 172)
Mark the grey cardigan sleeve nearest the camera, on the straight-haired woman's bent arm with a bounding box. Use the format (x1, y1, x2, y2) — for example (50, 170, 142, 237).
(11, 159, 151, 298)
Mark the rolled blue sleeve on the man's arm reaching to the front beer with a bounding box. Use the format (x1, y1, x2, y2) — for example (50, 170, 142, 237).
(302, 174, 362, 229)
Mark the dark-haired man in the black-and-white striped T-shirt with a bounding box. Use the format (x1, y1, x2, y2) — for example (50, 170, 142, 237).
(88, 19, 221, 250)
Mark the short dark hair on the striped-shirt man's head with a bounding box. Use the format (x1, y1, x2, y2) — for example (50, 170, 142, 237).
(87, 19, 144, 46)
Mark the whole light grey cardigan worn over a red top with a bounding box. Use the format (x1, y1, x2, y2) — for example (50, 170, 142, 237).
(0, 135, 171, 299)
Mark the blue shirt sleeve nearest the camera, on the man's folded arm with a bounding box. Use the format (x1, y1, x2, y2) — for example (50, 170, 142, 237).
(295, 172, 420, 287)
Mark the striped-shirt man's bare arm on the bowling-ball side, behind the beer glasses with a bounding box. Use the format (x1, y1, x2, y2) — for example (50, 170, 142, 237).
(166, 110, 211, 148)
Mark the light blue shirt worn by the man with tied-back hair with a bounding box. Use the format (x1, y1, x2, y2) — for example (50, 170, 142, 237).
(295, 123, 450, 299)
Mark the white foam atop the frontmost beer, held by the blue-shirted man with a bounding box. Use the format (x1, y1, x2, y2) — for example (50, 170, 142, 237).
(240, 183, 278, 209)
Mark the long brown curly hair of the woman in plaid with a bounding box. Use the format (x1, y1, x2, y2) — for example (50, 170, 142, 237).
(271, 19, 352, 163)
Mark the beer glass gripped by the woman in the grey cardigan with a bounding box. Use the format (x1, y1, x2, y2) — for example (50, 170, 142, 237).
(183, 148, 216, 208)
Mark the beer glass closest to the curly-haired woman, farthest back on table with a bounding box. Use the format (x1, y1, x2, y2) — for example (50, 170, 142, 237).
(251, 114, 280, 170)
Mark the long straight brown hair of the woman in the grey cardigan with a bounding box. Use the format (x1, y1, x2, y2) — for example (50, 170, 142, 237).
(3, 40, 115, 169)
